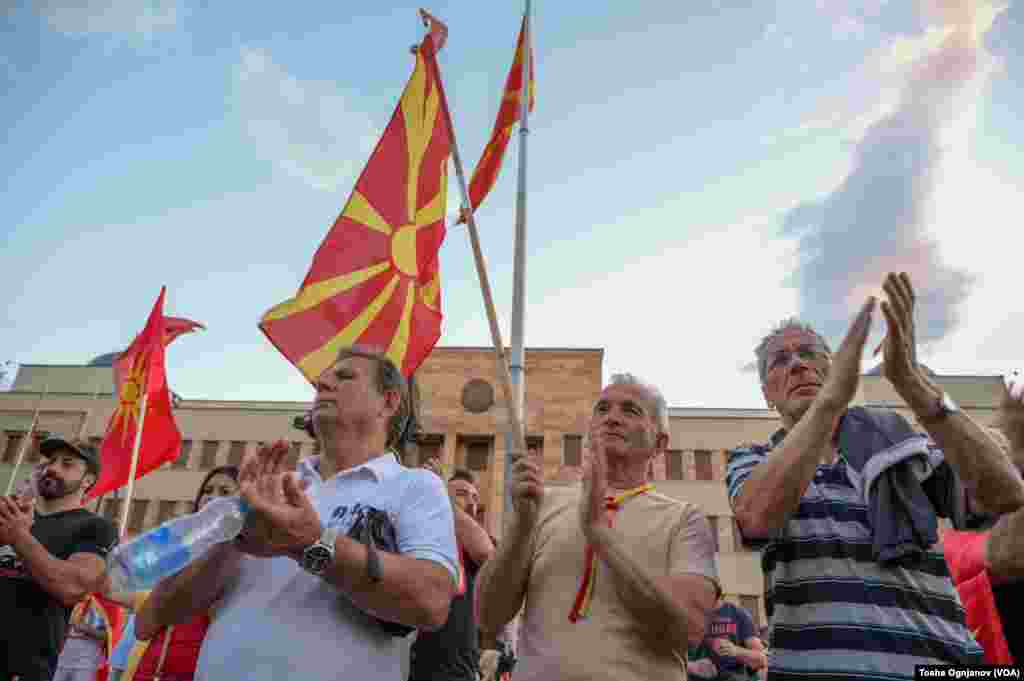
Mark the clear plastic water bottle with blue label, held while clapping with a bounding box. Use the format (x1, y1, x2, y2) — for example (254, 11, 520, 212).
(106, 497, 248, 592)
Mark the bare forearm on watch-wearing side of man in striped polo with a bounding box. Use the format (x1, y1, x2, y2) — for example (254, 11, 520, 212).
(899, 376, 1024, 513)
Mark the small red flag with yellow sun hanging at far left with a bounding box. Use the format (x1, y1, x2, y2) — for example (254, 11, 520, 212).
(86, 288, 181, 499)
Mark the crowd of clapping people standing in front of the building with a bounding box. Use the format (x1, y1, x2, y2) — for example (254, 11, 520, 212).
(0, 274, 1024, 681)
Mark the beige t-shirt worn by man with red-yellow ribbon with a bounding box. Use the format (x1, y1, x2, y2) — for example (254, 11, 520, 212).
(515, 485, 718, 681)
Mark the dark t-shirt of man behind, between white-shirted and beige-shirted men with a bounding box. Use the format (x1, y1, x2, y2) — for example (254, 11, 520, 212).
(409, 552, 480, 681)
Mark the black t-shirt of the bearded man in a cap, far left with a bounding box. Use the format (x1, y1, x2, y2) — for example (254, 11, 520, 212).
(0, 508, 118, 681)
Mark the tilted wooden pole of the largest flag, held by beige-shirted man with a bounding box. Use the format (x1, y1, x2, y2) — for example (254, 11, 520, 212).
(415, 18, 526, 493)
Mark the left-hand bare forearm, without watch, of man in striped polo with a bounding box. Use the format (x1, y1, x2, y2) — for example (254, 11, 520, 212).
(733, 401, 843, 539)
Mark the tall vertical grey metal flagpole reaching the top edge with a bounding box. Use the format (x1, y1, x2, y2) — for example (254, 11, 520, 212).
(504, 0, 532, 513)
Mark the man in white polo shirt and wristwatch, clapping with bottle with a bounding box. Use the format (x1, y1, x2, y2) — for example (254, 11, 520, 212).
(138, 348, 459, 681)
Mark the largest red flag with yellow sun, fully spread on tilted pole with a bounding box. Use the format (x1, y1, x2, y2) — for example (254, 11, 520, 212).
(259, 23, 451, 381)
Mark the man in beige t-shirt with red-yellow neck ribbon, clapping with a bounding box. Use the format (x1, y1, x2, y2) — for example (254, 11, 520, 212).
(476, 374, 719, 681)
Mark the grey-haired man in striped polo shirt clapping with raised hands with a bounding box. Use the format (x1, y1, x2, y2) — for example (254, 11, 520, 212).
(726, 273, 1024, 681)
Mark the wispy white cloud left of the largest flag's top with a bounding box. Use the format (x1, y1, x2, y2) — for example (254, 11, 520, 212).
(233, 48, 380, 191)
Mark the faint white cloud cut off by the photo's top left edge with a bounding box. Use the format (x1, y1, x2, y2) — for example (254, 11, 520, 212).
(35, 0, 182, 40)
